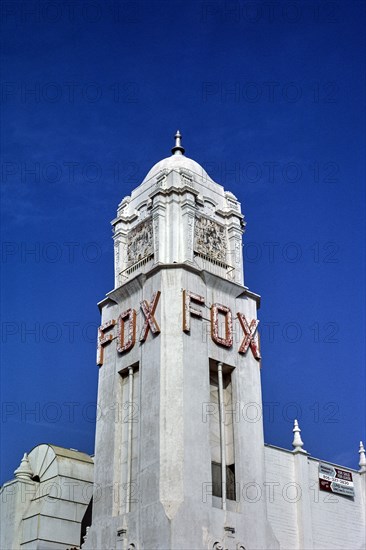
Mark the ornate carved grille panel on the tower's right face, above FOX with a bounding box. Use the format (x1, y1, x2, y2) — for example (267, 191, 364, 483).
(194, 216, 227, 263)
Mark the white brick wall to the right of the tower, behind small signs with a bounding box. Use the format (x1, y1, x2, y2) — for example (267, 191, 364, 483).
(265, 446, 366, 550)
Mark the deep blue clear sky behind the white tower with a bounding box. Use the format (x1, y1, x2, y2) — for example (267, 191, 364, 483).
(0, 0, 366, 482)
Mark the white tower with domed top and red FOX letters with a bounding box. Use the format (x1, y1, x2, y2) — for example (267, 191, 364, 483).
(83, 132, 279, 550)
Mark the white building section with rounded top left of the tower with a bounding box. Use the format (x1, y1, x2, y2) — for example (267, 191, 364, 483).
(0, 444, 93, 550)
